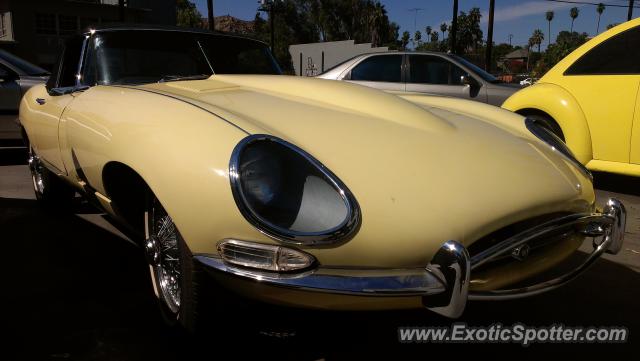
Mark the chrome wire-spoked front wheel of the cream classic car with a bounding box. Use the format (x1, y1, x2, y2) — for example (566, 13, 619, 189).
(145, 204, 182, 313)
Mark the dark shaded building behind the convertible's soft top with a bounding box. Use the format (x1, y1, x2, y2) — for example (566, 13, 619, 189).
(0, 0, 176, 68)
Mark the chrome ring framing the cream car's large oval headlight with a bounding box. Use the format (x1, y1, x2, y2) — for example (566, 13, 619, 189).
(229, 134, 362, 246)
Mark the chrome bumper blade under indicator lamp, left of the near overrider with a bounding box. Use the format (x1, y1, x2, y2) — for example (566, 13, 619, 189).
(194, 255, 445, 297)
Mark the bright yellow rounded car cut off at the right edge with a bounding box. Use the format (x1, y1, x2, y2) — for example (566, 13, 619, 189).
(502, 19, 640, 176)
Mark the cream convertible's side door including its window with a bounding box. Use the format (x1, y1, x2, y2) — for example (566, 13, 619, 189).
(30, 38, 83, 174)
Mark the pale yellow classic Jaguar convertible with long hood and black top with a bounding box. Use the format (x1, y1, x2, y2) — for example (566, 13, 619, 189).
(20, 28, 625, 328)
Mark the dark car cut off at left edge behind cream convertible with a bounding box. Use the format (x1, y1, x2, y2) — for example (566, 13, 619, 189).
(0, 49, 49, 111)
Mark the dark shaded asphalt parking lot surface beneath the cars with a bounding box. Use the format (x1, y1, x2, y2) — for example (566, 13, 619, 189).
(0, 142, 640, 360)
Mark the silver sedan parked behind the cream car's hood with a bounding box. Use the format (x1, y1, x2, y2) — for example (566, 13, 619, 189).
(318, 52, 521, 106)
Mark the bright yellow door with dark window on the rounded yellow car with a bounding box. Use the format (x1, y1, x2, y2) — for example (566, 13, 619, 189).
(559, 27, 640, 163)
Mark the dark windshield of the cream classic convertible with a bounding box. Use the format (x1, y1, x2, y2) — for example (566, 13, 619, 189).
(83, 30, 281, 85)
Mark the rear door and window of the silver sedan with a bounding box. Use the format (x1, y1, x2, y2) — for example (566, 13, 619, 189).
(344, 54, 405, 91)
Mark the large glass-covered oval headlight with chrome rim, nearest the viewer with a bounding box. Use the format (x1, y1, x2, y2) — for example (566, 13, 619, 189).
(229, 135, 360, 244)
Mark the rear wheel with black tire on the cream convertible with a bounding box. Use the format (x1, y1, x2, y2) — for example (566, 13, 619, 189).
(28, 146, 75, 208)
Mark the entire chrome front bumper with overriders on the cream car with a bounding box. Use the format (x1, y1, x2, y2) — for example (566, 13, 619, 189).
(195, 199, 626, 318)
